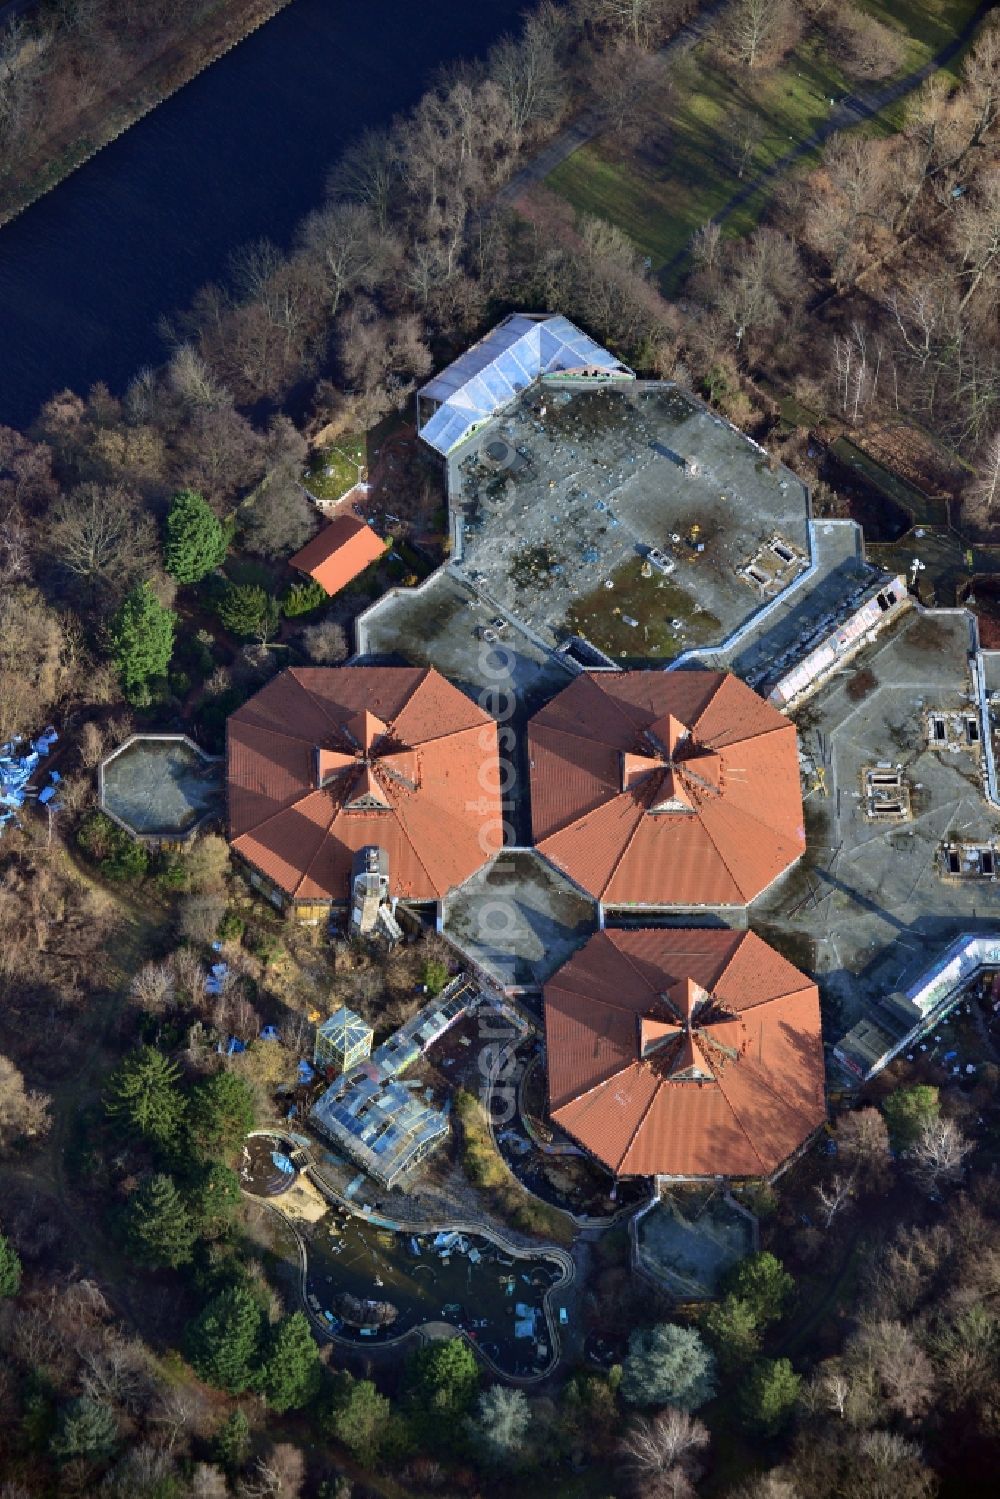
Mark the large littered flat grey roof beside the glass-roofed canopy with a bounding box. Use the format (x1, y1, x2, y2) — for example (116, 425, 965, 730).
(448, 382, 810, 664)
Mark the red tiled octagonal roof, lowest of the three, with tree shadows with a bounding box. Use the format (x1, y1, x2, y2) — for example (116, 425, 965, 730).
(544, 928, 826, 1177)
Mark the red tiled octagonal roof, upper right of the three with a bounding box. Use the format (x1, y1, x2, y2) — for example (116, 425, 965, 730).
(528, 672, 805, 905)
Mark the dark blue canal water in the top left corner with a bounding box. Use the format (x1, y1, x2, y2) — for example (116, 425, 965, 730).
(0, 0, 525, 426)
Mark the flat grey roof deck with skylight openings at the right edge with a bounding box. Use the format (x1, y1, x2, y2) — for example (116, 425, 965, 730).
(750, 610, 1000, 1040)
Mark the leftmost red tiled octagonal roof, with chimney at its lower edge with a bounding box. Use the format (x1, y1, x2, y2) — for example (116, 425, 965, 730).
(226, 667, 501, 901)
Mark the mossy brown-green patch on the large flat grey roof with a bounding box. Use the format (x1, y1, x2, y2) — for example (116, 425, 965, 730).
(565, 558, 718, 661)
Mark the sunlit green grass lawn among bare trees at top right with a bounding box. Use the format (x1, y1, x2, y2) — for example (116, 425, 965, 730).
(546, 0, 976, 295)
